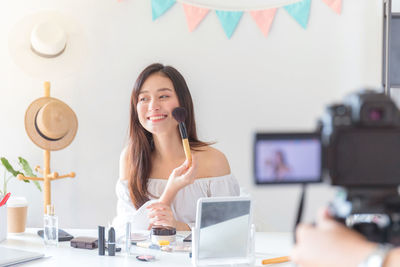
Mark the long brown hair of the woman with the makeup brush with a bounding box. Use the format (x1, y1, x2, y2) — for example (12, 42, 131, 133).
(125, 63, 209, 208)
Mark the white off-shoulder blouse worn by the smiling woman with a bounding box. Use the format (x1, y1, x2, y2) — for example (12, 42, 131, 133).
(112, 174, 240, 240)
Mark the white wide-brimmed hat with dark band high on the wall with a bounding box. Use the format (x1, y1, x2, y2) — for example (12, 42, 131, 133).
(8, 10, 87, 80)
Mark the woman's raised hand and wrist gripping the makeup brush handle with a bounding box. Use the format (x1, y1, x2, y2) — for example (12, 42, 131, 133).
(159, 155, 197, 206)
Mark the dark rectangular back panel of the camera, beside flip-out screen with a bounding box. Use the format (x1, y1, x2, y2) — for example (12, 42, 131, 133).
(330, 128, 400, 187)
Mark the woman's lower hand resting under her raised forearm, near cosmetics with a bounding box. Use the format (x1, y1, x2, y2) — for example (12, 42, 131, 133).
(147, 202, 177, 229)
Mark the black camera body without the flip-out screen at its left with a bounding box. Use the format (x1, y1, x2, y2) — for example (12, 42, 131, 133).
(320, 90, 400, 188)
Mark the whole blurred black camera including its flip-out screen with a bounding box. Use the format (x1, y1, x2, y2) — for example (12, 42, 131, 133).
(254, 90, 400, 245)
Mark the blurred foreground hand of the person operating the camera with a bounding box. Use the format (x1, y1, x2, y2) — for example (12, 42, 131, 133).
(291, 210, 376, 267)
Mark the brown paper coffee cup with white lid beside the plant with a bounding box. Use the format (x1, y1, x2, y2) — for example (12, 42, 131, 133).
(7, 197, 28, 233)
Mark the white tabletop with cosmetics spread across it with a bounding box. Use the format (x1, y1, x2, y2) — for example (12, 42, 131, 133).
(0, 228, 294, 267)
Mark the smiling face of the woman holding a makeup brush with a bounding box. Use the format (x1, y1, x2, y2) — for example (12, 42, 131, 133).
(136, 73, 179, 134)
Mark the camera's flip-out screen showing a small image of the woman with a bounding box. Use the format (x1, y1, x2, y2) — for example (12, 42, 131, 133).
(254, 133, 322, 184)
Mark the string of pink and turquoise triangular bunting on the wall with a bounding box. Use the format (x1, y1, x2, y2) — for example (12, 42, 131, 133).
(151, 0, 342, 38)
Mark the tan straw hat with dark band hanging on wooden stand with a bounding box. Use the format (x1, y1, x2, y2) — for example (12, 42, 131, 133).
(25, 97, 78, 151)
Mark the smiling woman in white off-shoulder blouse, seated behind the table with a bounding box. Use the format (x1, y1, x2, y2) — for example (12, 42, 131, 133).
(113, 64, 239, 239)
